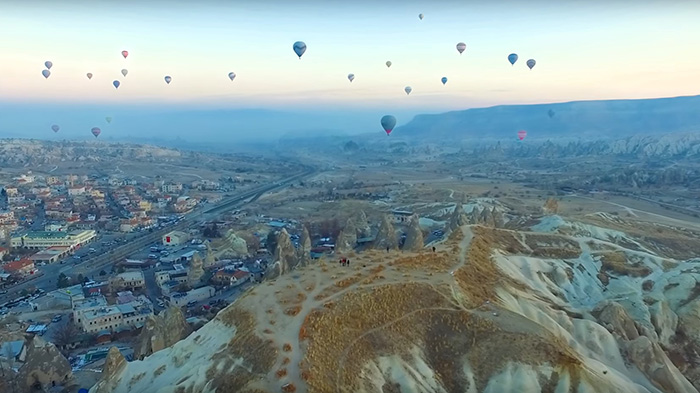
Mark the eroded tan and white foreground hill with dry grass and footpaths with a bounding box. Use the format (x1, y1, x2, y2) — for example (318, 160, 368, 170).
(91, 207, 700, 393)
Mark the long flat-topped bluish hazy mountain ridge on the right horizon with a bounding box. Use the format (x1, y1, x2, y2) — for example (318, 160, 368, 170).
(392, 96, 700, 140)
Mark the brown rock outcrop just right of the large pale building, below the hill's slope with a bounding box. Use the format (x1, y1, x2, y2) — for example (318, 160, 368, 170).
(134, 306, 192, 359)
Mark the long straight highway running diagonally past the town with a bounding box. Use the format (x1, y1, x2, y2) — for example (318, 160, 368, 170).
(0, 167, 316, 303)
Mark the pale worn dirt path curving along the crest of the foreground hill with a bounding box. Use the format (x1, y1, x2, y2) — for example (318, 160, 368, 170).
(243, 227, 473, 392)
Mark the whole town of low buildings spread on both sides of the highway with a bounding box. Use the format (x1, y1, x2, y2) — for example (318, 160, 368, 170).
(0, 166, 312, 383)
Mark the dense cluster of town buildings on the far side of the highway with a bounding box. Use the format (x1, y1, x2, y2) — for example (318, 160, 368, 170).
(0, 172, 227, 240)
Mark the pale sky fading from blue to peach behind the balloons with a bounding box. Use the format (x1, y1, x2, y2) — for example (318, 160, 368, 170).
(0, 0, 700, 110)
